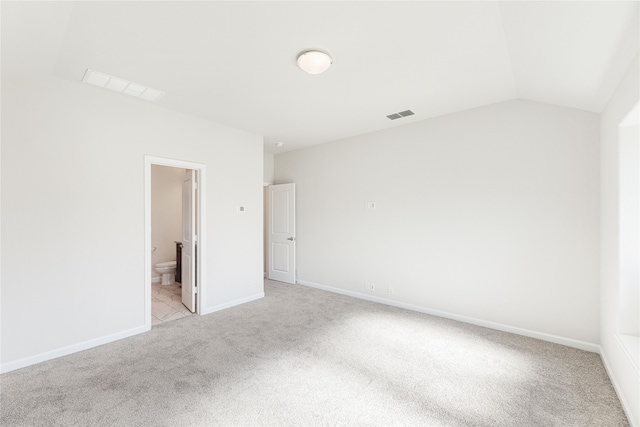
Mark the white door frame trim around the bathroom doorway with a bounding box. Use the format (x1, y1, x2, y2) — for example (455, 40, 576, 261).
(144, 155, 207, 330)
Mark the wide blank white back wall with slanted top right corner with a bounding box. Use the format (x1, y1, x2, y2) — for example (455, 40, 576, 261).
(275, 101, 599, 350)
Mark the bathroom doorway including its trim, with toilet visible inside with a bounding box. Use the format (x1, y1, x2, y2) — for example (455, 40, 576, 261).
(144, 156, 206, 329)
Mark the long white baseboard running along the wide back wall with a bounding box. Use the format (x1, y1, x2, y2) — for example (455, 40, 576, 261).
(296, 280, 600, 353)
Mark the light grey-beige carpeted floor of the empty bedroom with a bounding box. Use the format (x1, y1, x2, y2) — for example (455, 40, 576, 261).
(0, 281, 628, 427)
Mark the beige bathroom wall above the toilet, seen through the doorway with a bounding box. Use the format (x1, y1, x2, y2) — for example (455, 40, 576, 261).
(151, 165, 187, 279)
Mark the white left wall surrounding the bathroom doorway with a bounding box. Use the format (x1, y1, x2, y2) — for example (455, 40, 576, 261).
(1, 77, 263, 369)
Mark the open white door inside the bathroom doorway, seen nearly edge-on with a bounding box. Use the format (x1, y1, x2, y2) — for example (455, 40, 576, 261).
(182, 170, 198, 312)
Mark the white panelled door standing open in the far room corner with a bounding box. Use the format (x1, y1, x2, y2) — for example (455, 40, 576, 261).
(269, 184, 296, 284)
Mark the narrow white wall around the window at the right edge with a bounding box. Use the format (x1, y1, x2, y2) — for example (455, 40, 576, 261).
(600, 56, 640, 426)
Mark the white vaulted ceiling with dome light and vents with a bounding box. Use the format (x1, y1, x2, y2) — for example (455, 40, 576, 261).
(1, 1, 639, 153)
